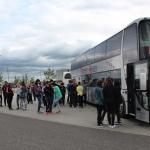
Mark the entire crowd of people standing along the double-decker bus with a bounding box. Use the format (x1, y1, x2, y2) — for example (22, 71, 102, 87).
(0, 78, 122, 128)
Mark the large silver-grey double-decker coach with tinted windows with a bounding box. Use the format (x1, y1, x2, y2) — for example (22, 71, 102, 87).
(71, 18, 150, 123)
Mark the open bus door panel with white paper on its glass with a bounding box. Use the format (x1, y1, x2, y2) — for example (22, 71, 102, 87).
(134, 62, 150, 123)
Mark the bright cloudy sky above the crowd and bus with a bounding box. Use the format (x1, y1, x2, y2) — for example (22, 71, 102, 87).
(0, 0, 150, 79)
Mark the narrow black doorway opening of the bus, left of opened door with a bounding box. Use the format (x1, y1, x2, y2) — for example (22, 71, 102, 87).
(127, 64, 135, 116)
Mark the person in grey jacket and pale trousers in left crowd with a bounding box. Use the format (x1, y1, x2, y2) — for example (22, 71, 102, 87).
(19, 82, 27, 110)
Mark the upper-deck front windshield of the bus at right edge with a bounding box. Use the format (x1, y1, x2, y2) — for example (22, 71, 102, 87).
(139, 20, 150, 59)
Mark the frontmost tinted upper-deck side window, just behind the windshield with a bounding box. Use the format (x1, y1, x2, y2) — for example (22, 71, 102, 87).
(123, 24, 138, 64)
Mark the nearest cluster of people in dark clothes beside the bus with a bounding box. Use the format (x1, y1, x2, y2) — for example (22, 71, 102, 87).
(95, 78, 123, 128)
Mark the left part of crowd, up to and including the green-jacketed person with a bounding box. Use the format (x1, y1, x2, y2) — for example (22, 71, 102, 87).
(0, 79, 66, 113)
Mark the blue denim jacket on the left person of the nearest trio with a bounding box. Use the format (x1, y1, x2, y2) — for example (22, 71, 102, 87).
(95, 87, 104, 105)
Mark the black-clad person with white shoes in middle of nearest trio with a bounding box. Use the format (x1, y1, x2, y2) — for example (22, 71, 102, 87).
(103, 78, 116, 128)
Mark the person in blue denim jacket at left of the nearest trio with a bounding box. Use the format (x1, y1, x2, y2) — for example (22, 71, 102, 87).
(95, 80, 104, 126)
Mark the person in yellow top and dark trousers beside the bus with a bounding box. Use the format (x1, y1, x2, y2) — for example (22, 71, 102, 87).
(76, 82, 83, 108)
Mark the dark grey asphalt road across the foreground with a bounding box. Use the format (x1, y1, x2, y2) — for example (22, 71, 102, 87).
(0, 114, 150, 150)
